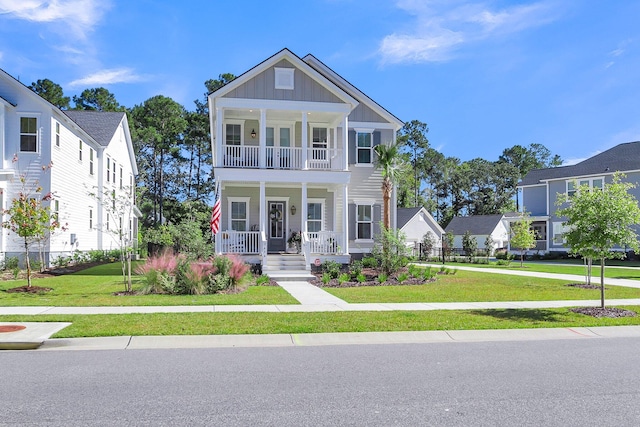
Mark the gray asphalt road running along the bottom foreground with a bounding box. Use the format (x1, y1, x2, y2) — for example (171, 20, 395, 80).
(0, 338, 640, 426)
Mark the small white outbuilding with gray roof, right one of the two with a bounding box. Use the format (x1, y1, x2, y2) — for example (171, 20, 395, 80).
(444, 213, 517, 254)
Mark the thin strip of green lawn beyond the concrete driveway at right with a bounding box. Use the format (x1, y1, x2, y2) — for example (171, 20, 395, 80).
(418, 260, 640, 280)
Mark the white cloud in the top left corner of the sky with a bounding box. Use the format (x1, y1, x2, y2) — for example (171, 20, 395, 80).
(0, 0, 110, 38)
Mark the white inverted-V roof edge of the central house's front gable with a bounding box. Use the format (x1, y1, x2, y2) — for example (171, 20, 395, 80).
(209, 48, 358, 109)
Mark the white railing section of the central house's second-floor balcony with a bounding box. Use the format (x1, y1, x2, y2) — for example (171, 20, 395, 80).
(225, 145, 344, 170)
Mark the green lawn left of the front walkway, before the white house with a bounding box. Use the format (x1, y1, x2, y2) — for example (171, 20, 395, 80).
(0, 263, 298, 307)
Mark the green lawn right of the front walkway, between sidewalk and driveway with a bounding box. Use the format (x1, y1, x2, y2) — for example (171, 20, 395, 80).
(324, 270, 640, 303)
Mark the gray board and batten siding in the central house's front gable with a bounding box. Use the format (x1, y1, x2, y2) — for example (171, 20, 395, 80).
(223, 59, 343, 103)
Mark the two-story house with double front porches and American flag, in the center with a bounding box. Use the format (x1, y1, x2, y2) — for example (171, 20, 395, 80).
(209, 49, 403, 270)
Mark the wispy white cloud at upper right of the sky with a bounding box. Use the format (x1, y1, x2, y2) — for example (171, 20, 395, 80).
(378, 0, 556, 63)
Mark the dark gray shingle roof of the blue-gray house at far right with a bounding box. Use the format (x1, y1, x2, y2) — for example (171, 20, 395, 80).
(519, 141, 640, 185)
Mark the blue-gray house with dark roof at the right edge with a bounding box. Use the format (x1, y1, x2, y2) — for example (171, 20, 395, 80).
(518, 141, 640, 252)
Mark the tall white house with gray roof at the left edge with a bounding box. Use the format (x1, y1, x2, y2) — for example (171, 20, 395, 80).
(0, 70, 139, 262)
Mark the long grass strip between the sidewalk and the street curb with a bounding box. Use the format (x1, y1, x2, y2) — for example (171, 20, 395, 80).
(0, 306, 640, 338)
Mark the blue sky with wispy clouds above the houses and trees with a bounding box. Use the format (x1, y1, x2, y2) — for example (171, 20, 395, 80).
(0, 0, 640, 166)
